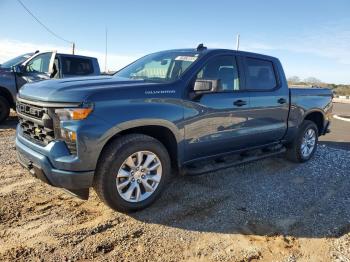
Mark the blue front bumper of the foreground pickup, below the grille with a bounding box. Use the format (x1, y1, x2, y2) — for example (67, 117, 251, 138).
(16, 136, 94, 199)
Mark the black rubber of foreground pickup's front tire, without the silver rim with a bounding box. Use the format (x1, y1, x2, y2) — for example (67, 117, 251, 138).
(94, 134, 171, 212)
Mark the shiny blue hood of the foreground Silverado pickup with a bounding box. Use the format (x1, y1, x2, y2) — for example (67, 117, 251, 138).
(19, 76, 154, 102)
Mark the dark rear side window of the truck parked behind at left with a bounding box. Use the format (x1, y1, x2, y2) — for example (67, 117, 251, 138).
(61, 57, 94, 75)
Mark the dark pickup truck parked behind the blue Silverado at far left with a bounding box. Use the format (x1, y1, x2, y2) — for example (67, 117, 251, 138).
(0, 51, 100, 123)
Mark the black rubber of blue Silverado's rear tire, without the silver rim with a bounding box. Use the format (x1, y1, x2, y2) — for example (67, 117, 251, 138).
(287, 120, 318, 163)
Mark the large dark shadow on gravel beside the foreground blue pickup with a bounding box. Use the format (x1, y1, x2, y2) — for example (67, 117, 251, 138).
(131, 146, 350, 238)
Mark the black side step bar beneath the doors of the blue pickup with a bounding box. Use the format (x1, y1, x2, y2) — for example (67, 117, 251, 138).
(182, 147, 286, 176)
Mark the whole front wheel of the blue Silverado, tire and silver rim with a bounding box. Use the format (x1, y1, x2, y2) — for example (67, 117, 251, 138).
(94, 134, 171, 212)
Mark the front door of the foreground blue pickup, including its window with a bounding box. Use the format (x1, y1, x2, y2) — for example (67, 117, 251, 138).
(184, 55, 250, 161)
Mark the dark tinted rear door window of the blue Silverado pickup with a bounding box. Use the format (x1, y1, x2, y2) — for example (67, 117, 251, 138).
(246, 58, 277, 90)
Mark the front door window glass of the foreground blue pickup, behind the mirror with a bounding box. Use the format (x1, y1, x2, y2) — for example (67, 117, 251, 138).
(197, 56, 239, 92)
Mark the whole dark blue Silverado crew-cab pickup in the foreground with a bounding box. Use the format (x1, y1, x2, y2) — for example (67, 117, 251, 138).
(16, 45, 332, 211)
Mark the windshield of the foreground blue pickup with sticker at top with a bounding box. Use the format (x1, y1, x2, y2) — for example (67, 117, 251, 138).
(114, 51, 199, 82)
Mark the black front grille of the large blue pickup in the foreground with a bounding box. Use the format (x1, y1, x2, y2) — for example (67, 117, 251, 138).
(16, 101, 55, 146)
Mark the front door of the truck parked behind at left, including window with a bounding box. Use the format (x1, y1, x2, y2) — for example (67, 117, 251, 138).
(17, 52, 56, 88)
